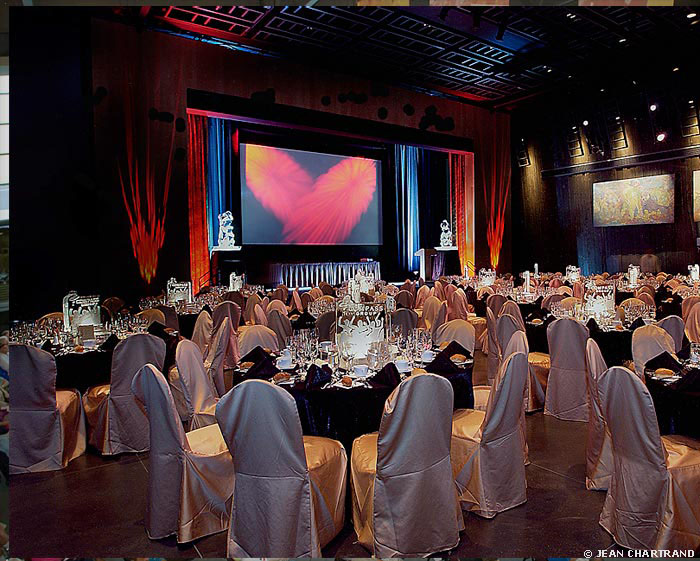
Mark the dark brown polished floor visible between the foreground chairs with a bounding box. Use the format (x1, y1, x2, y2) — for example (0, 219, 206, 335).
(10, 351, 617, 558)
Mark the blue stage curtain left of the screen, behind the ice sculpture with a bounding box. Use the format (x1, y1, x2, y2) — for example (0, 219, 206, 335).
(207, 117, 235, 251)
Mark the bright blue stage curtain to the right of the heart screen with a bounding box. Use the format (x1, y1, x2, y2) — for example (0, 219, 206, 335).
(394, 144, 422, 271)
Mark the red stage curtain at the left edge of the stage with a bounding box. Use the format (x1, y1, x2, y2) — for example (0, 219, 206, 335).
(187, 115, 209, 294)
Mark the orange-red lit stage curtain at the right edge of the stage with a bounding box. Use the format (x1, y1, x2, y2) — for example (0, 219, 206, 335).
(450, 153, 475, 275)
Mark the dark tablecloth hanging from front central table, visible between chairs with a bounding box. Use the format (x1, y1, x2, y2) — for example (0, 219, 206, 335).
(233, 364, 474, 450)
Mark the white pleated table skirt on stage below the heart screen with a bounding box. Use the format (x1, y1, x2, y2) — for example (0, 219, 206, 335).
(272, 261, 381, 288)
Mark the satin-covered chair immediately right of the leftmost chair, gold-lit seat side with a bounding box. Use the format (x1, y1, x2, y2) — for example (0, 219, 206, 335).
(83, 333, 165, 456)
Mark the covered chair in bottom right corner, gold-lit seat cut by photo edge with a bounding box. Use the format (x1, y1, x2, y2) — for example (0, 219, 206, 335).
(598, 366, 700, 550)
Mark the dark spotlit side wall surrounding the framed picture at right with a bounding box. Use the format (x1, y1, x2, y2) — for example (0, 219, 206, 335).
(512, 82, 700, 273)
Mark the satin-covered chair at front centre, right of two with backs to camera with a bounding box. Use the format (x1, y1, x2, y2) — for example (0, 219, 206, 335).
(350, 374, 464, 559)
